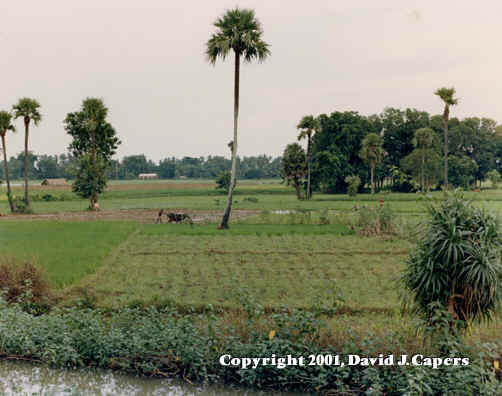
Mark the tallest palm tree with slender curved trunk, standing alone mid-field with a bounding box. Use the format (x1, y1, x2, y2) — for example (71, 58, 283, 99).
(206, 8, 270, 229)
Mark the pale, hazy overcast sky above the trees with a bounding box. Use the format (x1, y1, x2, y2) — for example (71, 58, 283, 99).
(0, 0, 502, 161)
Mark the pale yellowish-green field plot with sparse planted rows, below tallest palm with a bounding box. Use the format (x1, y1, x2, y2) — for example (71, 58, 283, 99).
(65, 230, 410, 311)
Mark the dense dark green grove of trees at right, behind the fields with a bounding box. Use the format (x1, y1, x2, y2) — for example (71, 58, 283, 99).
(282, 88, 502, 199)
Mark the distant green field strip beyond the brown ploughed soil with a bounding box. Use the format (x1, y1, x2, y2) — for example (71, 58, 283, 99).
(0, 179, 502, 216)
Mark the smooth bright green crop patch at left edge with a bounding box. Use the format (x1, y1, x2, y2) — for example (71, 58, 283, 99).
(0, 221, 135, 288)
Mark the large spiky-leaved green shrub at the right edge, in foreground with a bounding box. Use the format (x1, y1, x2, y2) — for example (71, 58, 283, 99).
(402, 191, 502, 325)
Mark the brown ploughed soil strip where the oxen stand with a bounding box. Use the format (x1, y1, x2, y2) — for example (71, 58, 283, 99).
(0, 208, 260, 224)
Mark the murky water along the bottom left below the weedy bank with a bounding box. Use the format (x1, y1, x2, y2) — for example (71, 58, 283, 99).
(0, 361, 286, 396)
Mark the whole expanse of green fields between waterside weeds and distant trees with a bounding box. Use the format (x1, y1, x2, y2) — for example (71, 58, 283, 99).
(0, 181, 502, 345)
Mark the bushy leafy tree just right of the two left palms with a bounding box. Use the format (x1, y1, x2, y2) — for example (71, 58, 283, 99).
(64, 98, 121, 210)
